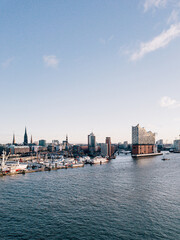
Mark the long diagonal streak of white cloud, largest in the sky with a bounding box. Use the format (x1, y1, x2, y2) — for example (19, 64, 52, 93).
(130, 23, 180, 61)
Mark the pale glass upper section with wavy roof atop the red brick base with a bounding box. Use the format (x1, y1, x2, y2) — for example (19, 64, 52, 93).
(132, 124, 155, 145)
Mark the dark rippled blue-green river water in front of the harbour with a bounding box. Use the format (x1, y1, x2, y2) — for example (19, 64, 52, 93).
(0, 154, 180, 240)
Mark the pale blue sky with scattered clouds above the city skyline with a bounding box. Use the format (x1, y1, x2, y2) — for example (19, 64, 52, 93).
(0, 0, 180, 143)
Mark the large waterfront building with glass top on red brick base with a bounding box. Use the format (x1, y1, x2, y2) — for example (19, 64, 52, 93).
(132, 124, 156, 155)
